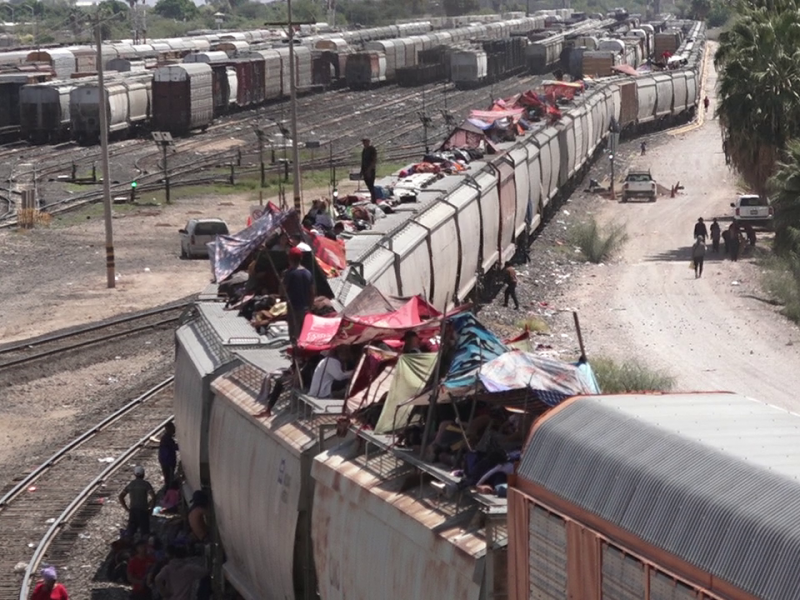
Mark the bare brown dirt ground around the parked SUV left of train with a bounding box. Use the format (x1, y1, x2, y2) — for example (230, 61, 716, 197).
(0, 182, 352, 342)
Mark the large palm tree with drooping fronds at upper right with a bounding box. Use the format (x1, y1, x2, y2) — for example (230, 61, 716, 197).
(714, 0, 800, 193)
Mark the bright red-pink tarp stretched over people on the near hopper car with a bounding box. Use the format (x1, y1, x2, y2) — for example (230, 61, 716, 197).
(297, 296, 441, 352)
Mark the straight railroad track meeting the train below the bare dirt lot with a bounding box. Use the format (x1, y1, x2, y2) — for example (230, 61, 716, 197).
(0, 302, 191, 372)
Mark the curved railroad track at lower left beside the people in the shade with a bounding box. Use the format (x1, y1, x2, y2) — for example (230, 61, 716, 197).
(0, 377, 174, 600)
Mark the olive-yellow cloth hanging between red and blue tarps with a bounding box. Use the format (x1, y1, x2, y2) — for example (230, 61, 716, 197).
(375, 353, 437, 434)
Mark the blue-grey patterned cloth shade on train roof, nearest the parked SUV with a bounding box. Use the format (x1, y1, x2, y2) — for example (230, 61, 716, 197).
(208, 210, 296, 282)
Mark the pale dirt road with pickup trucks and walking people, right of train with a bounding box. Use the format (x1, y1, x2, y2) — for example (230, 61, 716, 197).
(564, 47, 800, 410)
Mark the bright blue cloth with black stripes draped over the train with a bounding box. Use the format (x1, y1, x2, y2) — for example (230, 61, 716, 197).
(444, 313, 509, 392)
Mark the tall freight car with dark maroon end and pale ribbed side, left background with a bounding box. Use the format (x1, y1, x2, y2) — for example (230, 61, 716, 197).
(152, 63, 214, 135)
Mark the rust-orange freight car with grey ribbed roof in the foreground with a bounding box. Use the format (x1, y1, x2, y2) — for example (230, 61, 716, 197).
(506, 392, 800, 600)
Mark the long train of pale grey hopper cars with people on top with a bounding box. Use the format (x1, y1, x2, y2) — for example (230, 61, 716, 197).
(174, 18, 704, 600)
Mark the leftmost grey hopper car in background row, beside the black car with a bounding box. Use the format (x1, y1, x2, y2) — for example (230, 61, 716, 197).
(19, 81, 75, 144)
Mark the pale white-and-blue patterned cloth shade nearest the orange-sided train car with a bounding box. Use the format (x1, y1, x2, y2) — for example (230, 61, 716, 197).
(480, 350, 600, 406)
